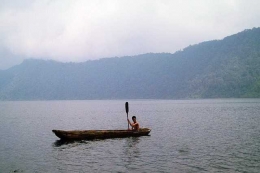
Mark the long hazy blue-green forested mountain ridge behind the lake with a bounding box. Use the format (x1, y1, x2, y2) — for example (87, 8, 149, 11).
(0, 28, 260, 100)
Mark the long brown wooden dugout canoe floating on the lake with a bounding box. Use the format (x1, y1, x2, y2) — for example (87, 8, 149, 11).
(52, 128, 151, 140)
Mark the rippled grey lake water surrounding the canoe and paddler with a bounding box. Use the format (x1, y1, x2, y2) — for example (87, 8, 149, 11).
(0, 99, 260, 173)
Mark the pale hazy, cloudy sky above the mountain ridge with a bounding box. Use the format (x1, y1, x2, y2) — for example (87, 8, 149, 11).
(0, 0, 260, 69)
